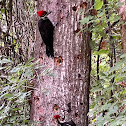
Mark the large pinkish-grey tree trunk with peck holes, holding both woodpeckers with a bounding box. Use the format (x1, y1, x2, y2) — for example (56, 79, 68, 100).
(31, 0, 91, 126)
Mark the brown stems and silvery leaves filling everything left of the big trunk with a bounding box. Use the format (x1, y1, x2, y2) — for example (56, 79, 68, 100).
(0, 0, 39, 126)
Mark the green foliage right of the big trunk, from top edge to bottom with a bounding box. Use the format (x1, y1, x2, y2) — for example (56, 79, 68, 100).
(80, 0, 126, 126)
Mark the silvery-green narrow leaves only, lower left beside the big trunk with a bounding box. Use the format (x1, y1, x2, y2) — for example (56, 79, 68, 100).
(0, 58, 37, 126)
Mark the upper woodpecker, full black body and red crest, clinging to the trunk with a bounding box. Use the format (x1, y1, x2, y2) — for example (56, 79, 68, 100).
(37, 10, 54, 57)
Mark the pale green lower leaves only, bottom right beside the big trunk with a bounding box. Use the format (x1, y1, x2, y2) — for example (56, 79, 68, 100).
(89, 56, 126, 126)
